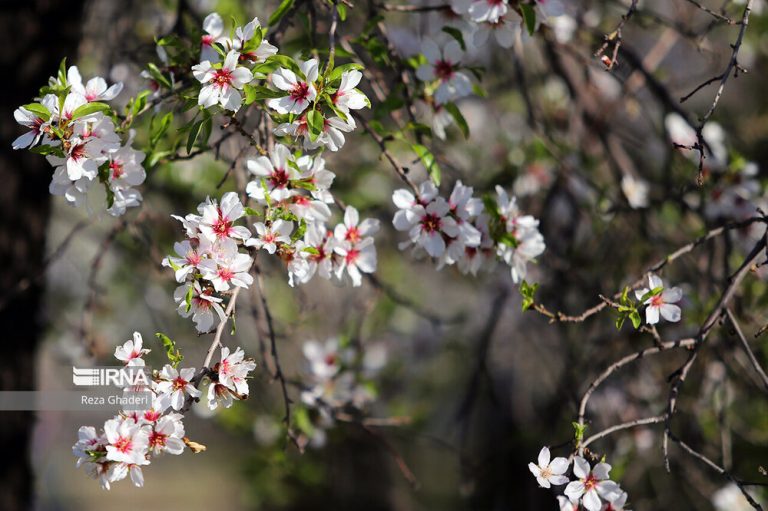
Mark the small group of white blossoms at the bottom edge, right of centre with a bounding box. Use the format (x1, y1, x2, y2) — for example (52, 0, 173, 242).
(528, 447, 627, 511)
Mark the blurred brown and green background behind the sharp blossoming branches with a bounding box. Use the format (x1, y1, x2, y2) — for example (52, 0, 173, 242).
(0, 0, 768, 511)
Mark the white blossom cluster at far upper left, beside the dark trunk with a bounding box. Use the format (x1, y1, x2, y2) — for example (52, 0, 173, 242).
(12, 66, 146, 216)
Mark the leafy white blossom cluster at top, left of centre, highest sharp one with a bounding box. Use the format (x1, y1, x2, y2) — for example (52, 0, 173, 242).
(192, 13, 370, 151)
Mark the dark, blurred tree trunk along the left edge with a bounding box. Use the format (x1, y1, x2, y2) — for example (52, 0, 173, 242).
(0, 0, 83, 511)
